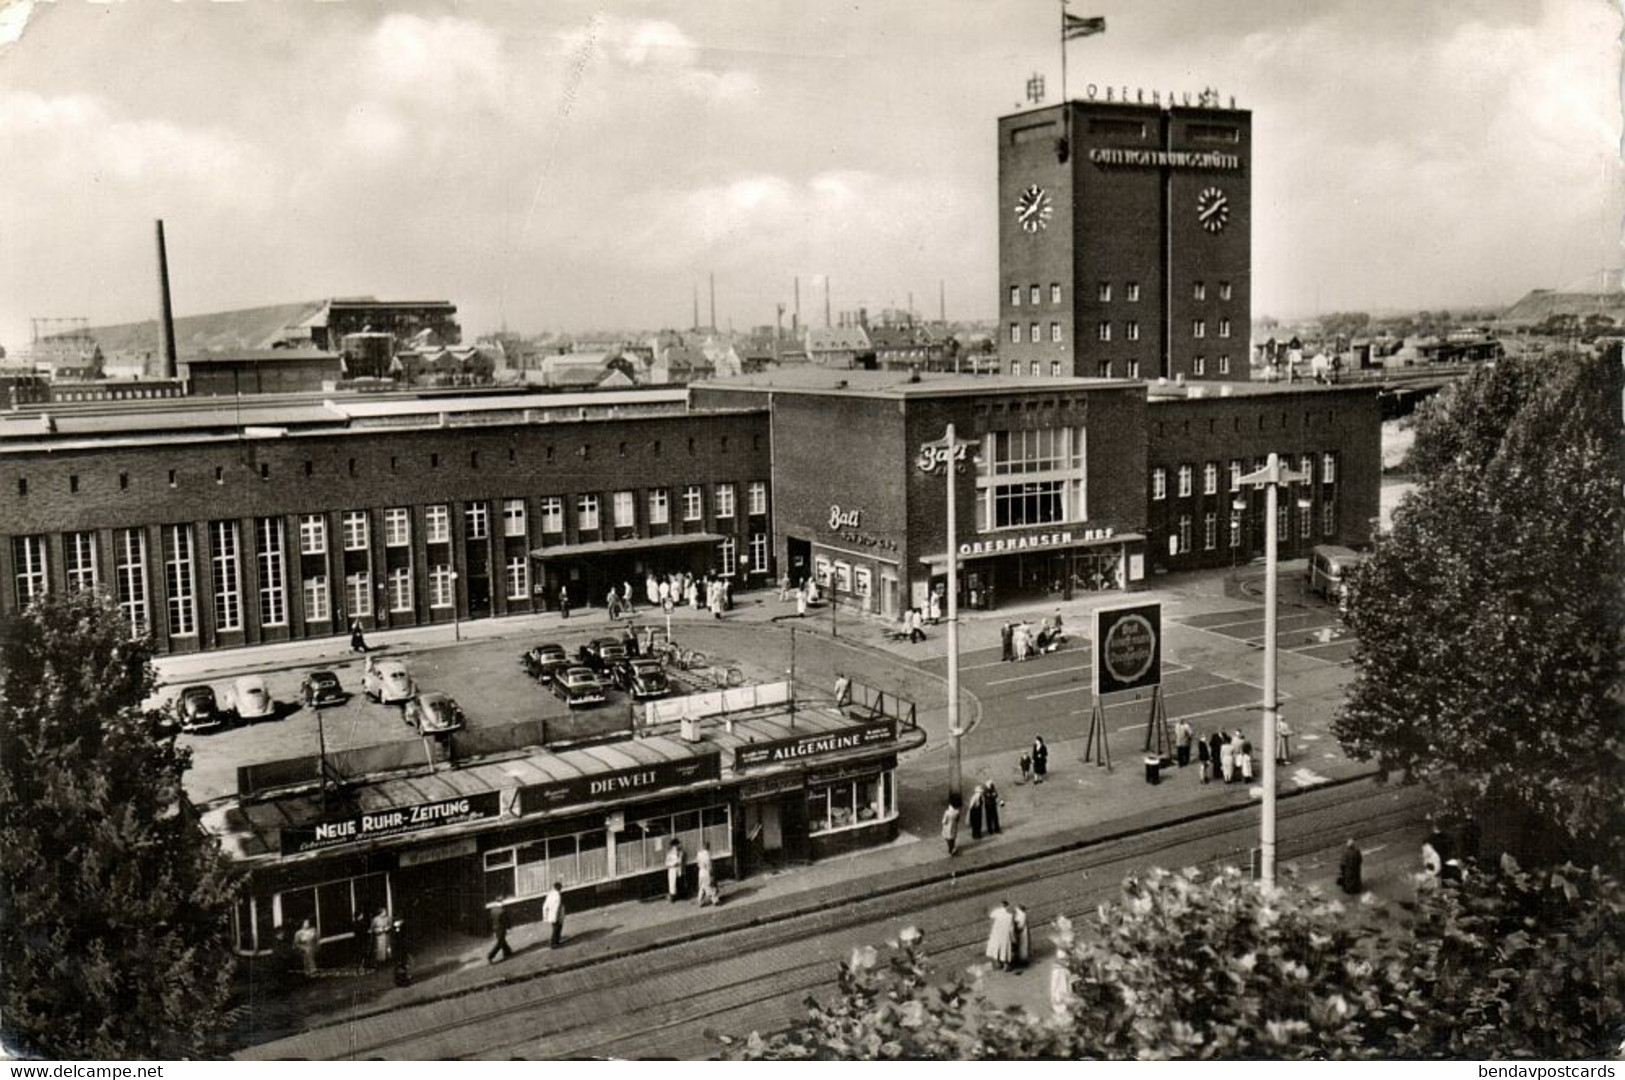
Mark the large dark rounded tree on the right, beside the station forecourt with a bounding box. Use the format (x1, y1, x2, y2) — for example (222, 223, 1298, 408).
(1334, 357, 1625, 866)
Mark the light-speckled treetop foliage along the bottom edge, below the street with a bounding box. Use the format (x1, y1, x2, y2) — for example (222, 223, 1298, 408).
(725, 858, 1625, 1061)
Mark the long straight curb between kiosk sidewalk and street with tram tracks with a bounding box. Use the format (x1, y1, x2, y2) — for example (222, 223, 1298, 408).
(242, 768, 1380, 1049)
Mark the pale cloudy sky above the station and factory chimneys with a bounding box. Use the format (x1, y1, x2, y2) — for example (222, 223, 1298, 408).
(0, 0, 1625, 348)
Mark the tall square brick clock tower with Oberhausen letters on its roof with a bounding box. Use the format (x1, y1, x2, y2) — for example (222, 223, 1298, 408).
(998, 91, 1251, 380)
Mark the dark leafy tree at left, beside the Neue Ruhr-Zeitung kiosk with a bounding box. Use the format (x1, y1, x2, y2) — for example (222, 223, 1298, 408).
(0, 591, 231, 1059)
